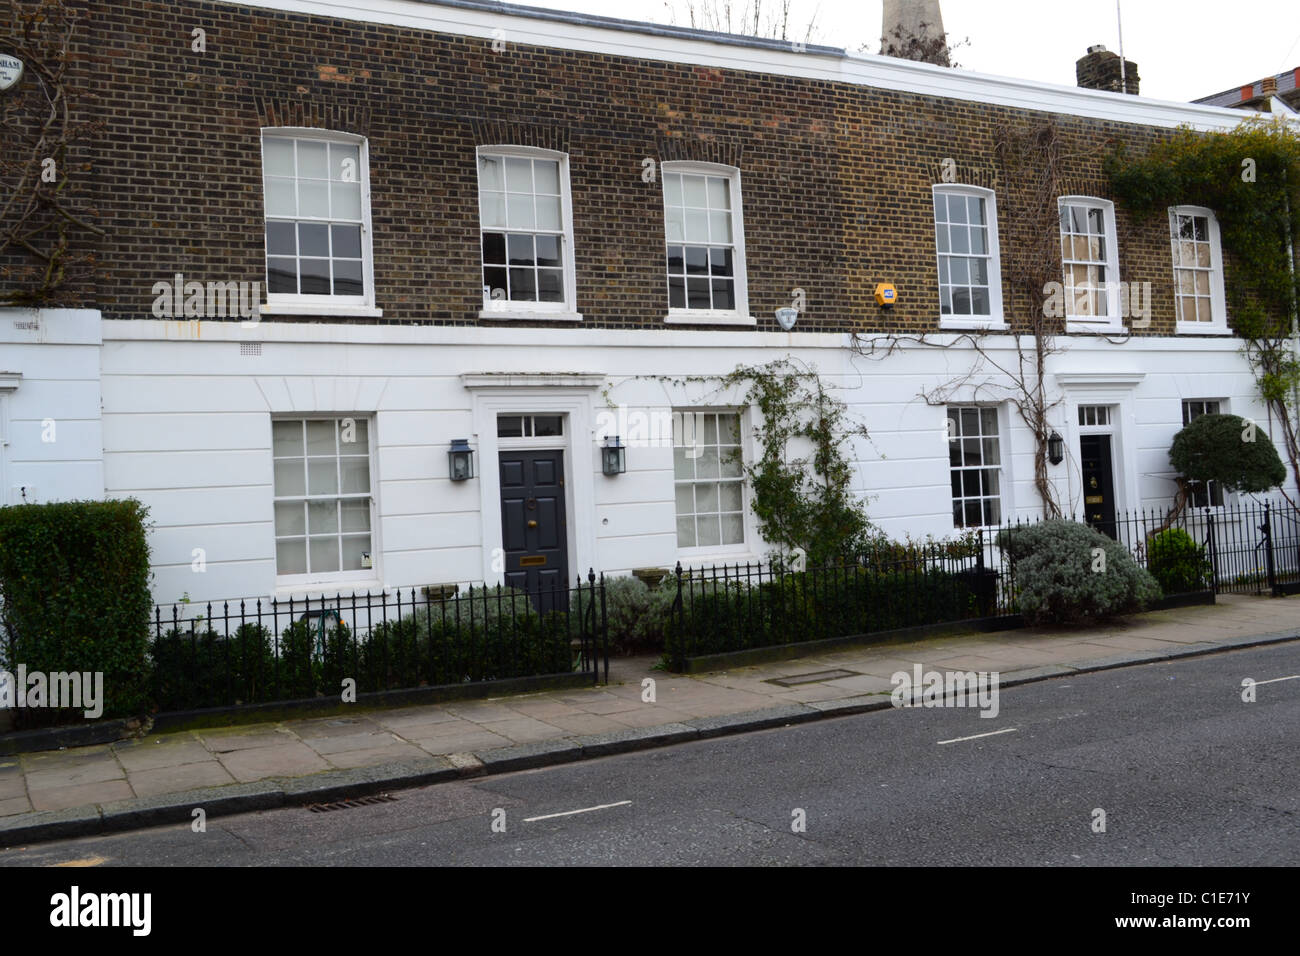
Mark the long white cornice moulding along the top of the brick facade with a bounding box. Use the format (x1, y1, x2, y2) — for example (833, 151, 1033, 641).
(228, 0, 1253, 130)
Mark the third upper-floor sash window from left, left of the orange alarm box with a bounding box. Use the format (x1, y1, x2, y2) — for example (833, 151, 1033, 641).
(663, 163, 753, 324)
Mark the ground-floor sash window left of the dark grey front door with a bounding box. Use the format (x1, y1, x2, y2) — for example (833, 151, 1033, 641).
(270, 418, 372, 578)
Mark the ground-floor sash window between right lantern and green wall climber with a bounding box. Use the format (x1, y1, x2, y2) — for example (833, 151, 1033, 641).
(672, 410, 745, 548)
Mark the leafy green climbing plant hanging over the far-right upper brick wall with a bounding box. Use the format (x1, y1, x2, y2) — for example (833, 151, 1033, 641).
(1106, 116, 1300, 510)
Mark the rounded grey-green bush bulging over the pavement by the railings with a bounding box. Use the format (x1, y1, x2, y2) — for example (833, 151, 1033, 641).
(997, 519, 1160, 624)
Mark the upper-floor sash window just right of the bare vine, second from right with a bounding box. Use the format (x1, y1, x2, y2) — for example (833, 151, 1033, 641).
(1060, 196, 1121, 329)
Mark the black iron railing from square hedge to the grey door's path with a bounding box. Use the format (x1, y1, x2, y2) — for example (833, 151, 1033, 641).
(151, 572, 608, 711)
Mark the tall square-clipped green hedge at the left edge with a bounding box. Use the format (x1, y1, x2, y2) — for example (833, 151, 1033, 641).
(0, 498, 153, 724)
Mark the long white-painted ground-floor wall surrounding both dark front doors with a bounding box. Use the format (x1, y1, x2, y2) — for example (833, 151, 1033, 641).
(103, 321, 1294, 601)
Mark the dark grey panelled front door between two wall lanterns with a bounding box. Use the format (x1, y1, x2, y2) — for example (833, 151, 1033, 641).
(501, 451, 568, 610)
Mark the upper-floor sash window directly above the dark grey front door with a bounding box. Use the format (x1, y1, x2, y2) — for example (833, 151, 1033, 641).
(478, 147, 582, 320)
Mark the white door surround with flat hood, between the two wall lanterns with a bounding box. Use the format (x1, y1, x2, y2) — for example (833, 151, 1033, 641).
(462, 373, 605, 585)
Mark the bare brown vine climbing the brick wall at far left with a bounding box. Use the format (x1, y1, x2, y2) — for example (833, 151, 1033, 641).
(0, 0, 104, 306)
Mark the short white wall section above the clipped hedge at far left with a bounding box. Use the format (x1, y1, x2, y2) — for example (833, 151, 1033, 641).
(0, 308, 104, 505)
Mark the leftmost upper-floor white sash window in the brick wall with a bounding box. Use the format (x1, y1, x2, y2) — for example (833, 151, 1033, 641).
(261, 129, 374, 312)
